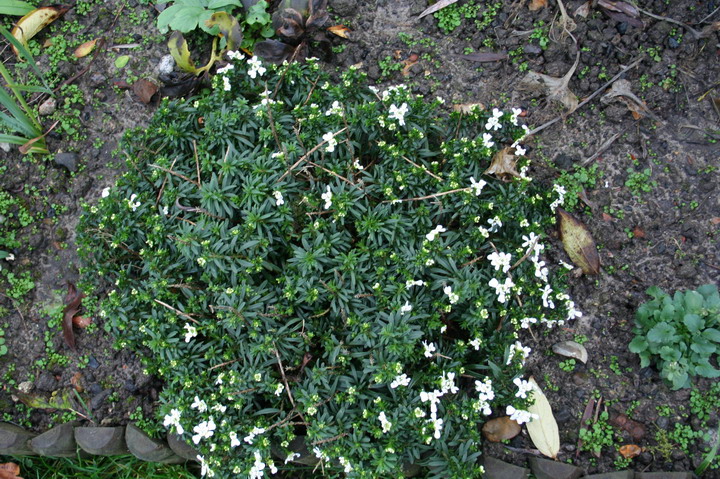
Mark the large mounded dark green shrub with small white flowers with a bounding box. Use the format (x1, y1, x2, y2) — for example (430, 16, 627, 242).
(79, 57, 580, 479)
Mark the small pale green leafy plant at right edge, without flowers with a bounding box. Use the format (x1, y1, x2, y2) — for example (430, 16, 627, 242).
(630, 284, 720, 389)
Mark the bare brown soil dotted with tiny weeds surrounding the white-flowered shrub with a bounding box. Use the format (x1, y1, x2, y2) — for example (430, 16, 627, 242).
(0, 0, 720, 478)
